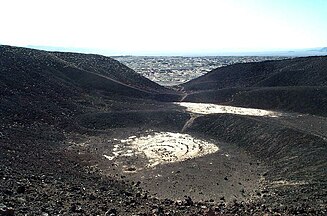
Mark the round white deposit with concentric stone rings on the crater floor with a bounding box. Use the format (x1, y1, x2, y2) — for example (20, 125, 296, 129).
(103, 132, 219, 167)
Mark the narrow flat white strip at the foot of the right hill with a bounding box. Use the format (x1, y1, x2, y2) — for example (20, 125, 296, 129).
(175, 102, 282, 117)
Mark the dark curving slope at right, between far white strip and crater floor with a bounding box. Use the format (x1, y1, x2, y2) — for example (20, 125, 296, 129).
(189, 114, 327, 208)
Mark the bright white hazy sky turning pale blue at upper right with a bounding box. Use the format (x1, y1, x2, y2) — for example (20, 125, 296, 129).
(0, 0, 327, 55)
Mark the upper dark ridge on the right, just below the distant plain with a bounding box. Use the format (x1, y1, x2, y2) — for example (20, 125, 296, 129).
(182, 56, 327, 91)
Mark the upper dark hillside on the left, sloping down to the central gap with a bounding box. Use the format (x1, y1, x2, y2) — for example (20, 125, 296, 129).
(0, 46, 179, 98)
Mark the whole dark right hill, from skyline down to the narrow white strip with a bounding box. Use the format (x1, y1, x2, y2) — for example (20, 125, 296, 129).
(182, 57, 327, 116)
